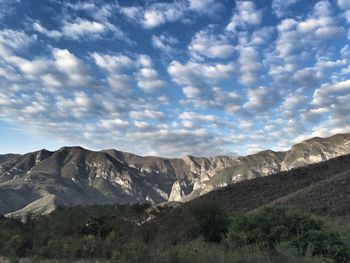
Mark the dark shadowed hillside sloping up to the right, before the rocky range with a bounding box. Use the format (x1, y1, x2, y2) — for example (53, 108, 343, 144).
(186, 155, 350, 215)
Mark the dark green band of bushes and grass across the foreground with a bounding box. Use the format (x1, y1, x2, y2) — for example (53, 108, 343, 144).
(0, 205, 350, 263)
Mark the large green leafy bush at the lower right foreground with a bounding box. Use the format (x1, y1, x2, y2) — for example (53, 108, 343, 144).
(226, 208, 349, 262)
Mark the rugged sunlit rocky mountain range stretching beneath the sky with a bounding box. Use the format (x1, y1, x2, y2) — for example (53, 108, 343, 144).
(0, 134, 350, 218)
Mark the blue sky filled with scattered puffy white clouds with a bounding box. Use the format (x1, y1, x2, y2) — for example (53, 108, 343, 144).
(0, 0, 350, 157)
